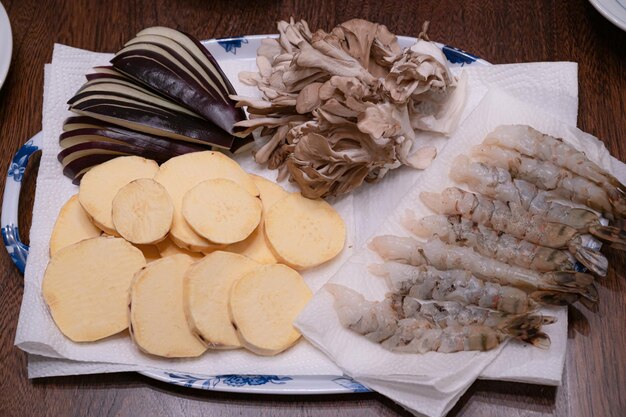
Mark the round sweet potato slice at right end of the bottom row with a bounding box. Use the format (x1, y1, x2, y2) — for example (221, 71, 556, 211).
(230, 264, 313, 355)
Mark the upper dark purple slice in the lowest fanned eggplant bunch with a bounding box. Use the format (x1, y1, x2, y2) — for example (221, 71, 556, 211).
(59, 127, 206, 155)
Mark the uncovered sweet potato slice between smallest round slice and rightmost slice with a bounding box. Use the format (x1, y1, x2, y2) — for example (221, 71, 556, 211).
(182, 178, 263, 244)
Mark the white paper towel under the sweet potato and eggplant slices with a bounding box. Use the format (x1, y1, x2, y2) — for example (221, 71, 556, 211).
(15, 45, 346, 375)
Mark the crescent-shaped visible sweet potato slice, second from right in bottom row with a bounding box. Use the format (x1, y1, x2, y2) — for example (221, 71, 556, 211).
(184, 251, 261, 349)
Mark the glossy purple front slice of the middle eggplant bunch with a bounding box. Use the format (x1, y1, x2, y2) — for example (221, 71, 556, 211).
(70, 97, 234, 149)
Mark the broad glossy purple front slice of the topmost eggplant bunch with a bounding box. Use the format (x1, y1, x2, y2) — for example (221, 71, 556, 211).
(111, 50, 241, 133)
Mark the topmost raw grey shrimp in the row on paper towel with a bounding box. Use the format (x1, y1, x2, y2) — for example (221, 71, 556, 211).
(483, 125, 626, 194)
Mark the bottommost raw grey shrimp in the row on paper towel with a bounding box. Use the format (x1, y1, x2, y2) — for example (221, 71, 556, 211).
(325, 284, 550, 353)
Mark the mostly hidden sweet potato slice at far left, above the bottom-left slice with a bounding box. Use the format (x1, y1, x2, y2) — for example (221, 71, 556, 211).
(50, 194, 102, 256)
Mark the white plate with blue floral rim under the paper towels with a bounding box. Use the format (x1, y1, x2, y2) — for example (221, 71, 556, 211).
(0, 33, 491, 395)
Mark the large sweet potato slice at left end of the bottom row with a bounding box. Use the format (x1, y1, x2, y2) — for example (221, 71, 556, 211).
(42, 237, 146, 342)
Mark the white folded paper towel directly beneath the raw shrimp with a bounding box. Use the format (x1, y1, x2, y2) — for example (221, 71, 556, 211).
(295, 89, 626, 416)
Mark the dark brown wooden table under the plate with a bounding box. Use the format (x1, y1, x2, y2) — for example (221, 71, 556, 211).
(0, 0, 626, 417)
